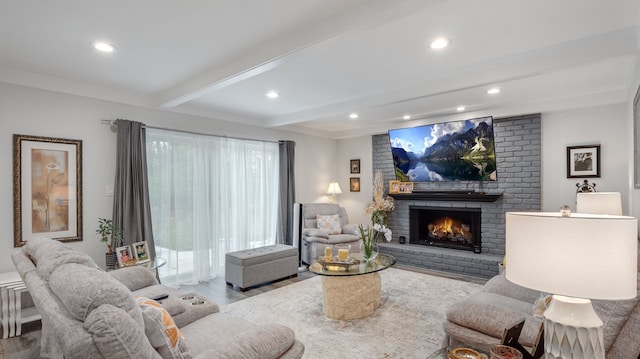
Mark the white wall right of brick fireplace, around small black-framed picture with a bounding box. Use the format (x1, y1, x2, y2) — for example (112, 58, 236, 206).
(542, 103, 633, 214)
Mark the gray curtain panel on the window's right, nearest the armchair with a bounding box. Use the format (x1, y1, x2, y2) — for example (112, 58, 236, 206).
(276, 141, 296, 245)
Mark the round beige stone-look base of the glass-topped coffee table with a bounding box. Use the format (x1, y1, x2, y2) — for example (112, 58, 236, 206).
(322, 272, 382, 320)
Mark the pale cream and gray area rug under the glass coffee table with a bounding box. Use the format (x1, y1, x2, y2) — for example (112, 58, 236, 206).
(221, 268, 480, 359)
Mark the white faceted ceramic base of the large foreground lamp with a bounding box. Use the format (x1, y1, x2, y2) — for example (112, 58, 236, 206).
(544, 295, 604, 359)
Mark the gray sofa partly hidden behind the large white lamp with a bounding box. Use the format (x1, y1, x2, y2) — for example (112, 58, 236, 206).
(444, 262, 640, 359)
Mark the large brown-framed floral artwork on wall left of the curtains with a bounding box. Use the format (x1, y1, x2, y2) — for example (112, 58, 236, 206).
(13, 134, 82, 247)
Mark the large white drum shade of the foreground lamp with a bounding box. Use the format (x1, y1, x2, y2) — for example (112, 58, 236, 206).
(505, 212, 638, 299)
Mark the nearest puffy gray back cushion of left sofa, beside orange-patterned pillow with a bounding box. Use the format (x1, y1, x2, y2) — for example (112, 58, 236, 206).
(84, 304, 160, 359)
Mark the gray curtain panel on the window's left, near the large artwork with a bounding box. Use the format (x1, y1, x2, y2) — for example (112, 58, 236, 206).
(113, 119, 156, 258)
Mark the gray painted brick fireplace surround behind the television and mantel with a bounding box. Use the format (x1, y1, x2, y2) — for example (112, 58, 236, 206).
(372, 114, 541, 278)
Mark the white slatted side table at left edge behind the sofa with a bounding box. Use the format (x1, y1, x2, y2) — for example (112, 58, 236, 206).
(0, 272, 41, 339)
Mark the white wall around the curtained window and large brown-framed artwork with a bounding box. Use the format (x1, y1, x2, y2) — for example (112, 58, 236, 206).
(0, 83, 338, 272)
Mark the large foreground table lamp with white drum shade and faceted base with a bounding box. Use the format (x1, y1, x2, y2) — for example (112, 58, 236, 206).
(505, 212, 638, 359)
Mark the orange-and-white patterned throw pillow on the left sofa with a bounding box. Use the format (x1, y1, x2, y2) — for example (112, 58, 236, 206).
(135, 296, 191, 359)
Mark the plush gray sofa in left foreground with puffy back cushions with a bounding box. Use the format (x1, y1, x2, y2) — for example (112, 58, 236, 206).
(12, 238, 304, 359)
